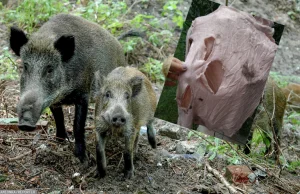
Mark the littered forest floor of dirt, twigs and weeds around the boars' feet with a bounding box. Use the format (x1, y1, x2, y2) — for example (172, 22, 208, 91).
(0, 75, 300, 194)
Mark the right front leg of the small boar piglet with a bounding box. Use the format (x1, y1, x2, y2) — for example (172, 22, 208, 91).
(124, 129, 136, 179)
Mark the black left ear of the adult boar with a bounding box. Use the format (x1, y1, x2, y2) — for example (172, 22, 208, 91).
(9, 26, 28, 56)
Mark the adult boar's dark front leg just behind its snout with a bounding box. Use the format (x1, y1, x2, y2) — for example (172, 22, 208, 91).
(50, 106, 68, 141)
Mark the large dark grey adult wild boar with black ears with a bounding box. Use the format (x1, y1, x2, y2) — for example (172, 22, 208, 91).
(10, 14, 125, 162)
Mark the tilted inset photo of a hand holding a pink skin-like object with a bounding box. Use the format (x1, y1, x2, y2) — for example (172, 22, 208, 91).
(155, 0, 285, 144)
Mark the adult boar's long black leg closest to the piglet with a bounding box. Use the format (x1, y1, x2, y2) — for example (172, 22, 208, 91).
(74, 95, 89, 163)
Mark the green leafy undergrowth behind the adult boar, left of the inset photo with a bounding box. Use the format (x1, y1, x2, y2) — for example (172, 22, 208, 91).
(0, 0, 188, 83)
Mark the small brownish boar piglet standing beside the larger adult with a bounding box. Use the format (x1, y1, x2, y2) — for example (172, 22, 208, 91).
(95, 67, 156, 178)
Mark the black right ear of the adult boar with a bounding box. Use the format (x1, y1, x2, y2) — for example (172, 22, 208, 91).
(54, 35, 75, 62)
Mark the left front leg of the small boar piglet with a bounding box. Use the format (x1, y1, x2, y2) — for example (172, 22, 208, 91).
(96, 132, 107, 178)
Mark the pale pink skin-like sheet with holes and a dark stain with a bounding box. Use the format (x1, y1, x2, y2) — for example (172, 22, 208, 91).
(177, 6, 277, 137)
